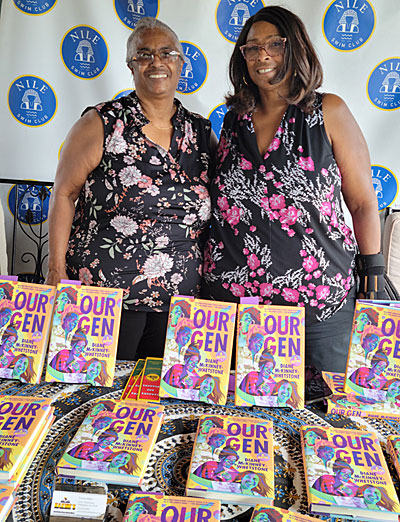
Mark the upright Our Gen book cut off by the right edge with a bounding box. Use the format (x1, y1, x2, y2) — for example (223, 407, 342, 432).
(344, 302, 400, 400)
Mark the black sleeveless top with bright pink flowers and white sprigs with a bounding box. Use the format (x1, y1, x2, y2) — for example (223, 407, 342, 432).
(203, 94, 356, 324)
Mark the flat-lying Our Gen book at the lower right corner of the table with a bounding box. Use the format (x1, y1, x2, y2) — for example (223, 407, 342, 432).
(300, 426, 400, 522)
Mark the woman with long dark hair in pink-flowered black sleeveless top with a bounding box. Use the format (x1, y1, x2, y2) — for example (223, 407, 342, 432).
(203, 6, 383, 372)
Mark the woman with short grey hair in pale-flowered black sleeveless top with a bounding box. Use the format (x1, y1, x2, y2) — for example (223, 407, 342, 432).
(47, 18, 216, 359)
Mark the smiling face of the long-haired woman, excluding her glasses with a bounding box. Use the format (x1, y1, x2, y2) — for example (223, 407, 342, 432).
(246, 22, 284, 91)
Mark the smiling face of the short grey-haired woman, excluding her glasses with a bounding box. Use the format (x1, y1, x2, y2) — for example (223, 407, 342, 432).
(130, 29, 183, 98)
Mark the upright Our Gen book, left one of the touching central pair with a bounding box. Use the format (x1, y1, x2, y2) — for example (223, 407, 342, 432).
(160, 296, 236, 404)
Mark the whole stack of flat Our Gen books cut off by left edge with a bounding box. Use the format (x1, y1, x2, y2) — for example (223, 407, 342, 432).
(0, 396, 54, 520)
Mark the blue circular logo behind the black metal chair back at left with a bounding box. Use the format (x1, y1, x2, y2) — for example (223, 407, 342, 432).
(8, 185, 50, 225)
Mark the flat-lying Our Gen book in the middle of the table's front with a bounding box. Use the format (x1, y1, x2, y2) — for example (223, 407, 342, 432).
(186, 415, 274, 505)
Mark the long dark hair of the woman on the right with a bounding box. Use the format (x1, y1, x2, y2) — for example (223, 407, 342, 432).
(225, 6, 323, 114)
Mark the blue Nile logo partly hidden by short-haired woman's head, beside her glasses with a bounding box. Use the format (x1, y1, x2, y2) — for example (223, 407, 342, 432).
(177, 42, 208, 94)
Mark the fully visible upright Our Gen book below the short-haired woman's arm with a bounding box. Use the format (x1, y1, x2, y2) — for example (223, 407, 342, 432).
(46, 283, 122, 386)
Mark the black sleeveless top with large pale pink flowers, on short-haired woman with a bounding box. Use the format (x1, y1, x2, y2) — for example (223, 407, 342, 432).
(67, 92, 211, 312)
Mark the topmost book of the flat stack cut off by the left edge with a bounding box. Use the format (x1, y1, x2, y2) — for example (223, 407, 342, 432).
(0, 395, 52, 482)
